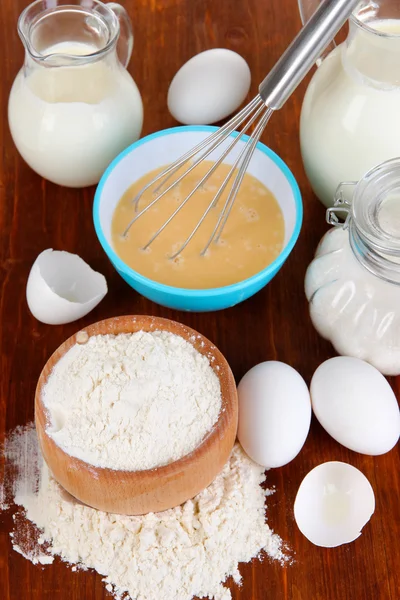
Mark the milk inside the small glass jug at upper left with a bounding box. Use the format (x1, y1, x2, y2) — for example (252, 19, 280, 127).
(8, 42, 143, 187)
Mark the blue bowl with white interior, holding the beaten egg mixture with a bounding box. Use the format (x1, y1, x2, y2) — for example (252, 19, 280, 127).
(93, 125, 303, 312)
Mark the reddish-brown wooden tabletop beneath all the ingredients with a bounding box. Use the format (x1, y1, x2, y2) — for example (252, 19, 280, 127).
(0, 0, 400, 600)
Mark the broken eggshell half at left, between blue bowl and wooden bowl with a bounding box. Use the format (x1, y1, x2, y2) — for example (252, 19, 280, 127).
(26, 248, 107, 325)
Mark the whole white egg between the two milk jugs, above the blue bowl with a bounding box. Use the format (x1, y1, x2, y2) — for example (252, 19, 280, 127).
(168, 48, 251, 125)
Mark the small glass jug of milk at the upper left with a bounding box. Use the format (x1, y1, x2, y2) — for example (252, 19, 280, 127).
(8, 0, 143, 187)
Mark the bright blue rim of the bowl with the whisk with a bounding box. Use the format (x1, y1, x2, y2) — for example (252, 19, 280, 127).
(93, 125, 303, 298)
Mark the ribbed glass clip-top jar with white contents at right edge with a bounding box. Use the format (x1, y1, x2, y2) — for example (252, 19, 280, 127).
(305, 158, 400, 375)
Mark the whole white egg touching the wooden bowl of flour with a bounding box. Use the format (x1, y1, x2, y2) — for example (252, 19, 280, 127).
(238, 361, 311, 469)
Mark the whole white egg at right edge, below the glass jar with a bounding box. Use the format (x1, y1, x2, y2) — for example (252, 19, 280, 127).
(310, 356, 400, 456)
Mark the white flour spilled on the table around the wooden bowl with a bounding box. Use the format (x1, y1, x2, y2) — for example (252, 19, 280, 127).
(1, 424, 287, 600)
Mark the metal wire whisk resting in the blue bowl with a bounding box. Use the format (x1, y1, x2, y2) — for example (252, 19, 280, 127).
(123, 0, 359, 259)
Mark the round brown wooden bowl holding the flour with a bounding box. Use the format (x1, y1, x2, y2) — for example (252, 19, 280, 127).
(35, 316, 238, 515)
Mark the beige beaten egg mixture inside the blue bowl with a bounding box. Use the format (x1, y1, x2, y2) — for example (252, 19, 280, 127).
(112, 161, 285, 289)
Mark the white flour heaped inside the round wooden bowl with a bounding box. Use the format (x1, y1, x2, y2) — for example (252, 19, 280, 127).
(43, 331, 221, 471)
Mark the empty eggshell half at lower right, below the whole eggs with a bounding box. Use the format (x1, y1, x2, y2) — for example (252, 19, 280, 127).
(294, 462, 375, 548)
